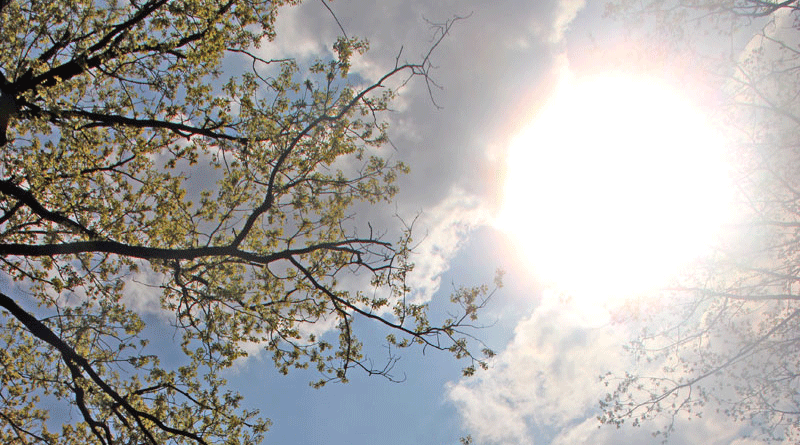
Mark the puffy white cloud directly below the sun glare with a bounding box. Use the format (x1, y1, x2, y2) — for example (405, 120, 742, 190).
(449, 291, 628, 444)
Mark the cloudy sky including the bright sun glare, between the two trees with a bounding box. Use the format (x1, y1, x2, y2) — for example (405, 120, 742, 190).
(139, 0, 776, 445)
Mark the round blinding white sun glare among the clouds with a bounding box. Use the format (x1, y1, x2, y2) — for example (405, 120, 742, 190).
(498, 75, 730, 299)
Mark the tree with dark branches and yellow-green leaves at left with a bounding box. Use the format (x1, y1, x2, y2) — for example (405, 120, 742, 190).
(0, 0, 500, 445)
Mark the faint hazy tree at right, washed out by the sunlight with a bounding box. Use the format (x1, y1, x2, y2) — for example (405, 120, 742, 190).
(601, 0, 800, 443)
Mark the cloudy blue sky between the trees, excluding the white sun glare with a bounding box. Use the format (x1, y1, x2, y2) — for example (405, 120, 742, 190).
(119, 0, 776, 445)
